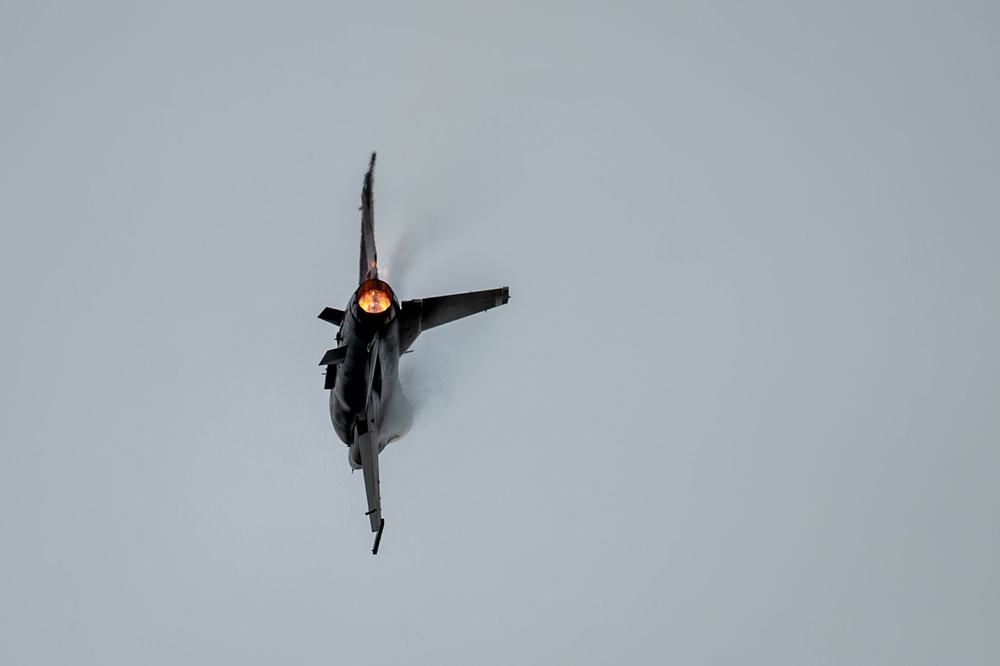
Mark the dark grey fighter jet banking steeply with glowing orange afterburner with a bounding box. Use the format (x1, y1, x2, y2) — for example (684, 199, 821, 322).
(319, 153, 510, 554)
